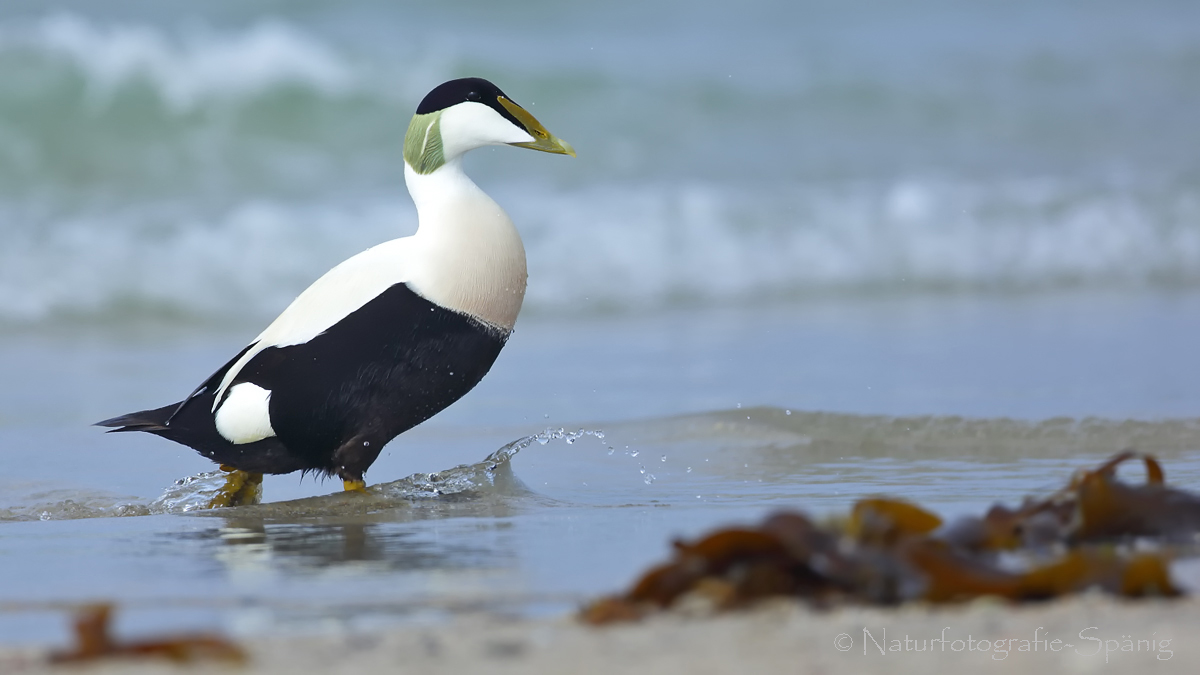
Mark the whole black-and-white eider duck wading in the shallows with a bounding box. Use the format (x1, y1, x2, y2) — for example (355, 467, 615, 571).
(97, 78, 575, 499)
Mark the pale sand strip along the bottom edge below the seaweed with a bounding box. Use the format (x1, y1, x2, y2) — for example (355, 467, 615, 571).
(0, 595, 1200, 675)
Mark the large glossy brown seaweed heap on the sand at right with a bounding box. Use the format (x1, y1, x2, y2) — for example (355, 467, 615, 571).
(581, 452, 1200, 625)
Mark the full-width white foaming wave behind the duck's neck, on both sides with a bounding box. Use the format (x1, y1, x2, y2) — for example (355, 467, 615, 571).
(0, 179, 1200, 323)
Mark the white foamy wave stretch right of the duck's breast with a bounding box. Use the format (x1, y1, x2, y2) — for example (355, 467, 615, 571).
(514, 180, 1200, 307)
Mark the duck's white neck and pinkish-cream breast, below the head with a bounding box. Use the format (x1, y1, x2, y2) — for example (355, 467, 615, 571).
(404, 156, 528, 330)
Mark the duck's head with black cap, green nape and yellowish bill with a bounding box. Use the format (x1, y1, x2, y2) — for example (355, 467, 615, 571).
(404, 77, 575, 173)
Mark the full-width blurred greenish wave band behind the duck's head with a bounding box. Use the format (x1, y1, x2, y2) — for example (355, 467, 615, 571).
(0, 9, 1200, 199)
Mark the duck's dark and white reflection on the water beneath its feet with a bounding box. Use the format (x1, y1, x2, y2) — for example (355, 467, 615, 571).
(164, 495, 540, 633)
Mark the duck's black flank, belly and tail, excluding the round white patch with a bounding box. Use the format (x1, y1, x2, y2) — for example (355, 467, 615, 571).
(100, 283, 508, 480)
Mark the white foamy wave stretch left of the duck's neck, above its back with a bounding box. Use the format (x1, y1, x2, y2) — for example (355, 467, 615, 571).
(0, 201, 415, 322)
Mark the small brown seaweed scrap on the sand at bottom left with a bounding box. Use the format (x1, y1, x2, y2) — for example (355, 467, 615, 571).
(50, 603, 246, 665)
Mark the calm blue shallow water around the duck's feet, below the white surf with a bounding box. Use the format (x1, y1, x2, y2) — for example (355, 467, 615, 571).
(0, 293, 1200, 643)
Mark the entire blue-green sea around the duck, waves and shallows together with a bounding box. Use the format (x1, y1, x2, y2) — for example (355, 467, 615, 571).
(0, 0, 1200, 641)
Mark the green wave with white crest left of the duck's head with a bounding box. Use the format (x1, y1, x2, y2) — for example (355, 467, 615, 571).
(0, 13, 436, 198)
